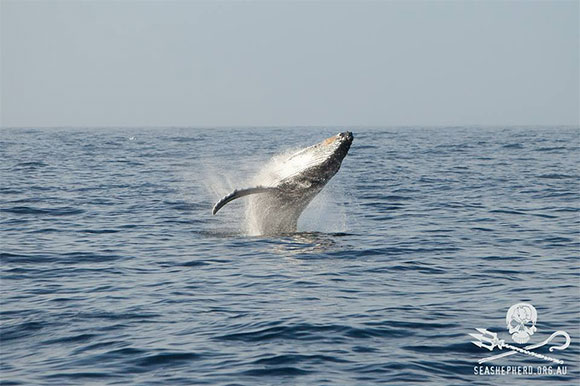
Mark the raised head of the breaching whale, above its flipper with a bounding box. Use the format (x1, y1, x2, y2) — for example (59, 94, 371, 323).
(278, 131, 353, 189)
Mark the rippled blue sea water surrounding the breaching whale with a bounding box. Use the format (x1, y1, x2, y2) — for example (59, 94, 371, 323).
(0, 127, 580, 385)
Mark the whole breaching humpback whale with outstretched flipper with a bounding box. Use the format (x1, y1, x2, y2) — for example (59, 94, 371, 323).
(212, 131, 353, 235)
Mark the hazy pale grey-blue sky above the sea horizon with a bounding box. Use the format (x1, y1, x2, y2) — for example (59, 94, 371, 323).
(0, 0, 580, 127)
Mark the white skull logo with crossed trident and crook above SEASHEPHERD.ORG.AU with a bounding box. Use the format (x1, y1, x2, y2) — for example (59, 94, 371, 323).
(469, 303, 570, 375)
